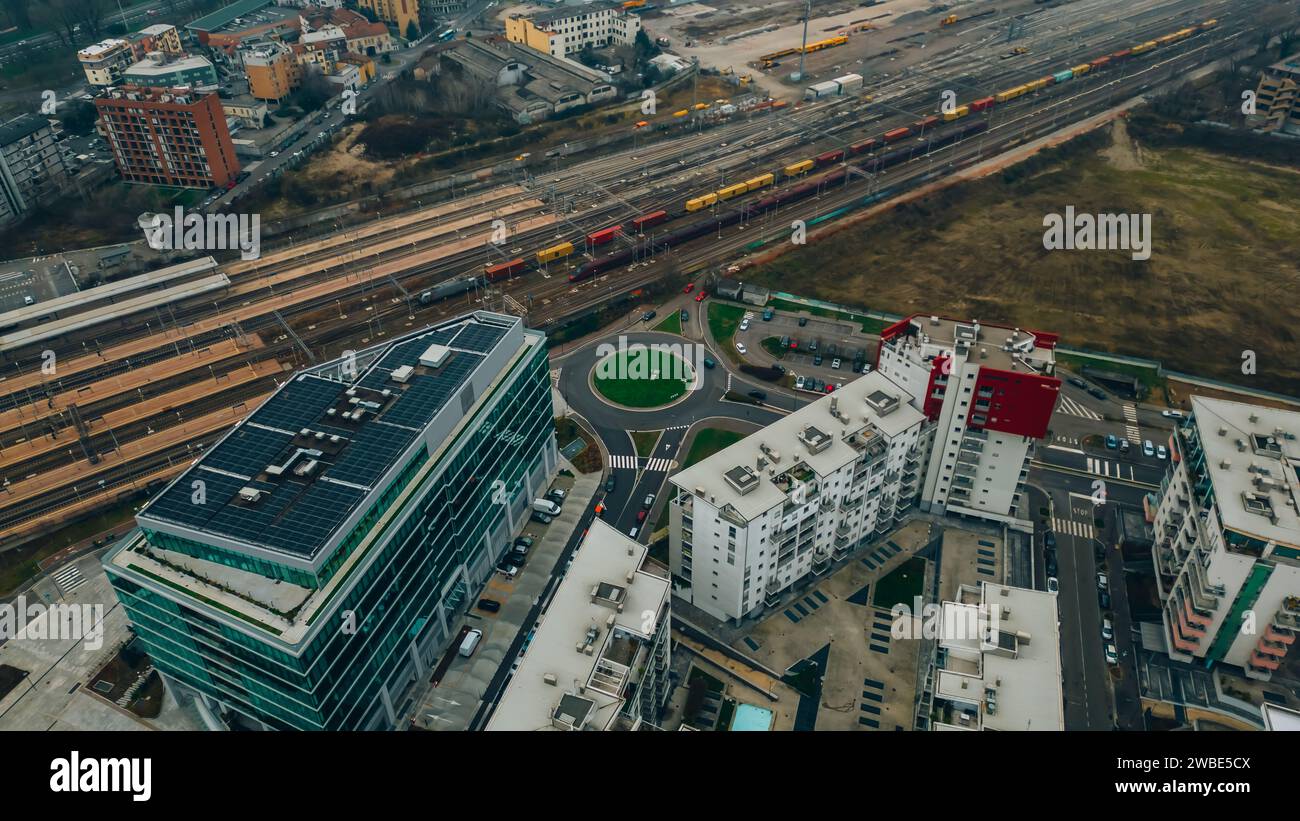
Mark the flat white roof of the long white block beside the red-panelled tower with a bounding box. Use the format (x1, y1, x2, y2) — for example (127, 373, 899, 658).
(671, 372, 926, 521)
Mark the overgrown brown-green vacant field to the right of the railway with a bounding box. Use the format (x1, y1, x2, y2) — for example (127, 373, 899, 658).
(744, 126, 1300, 395)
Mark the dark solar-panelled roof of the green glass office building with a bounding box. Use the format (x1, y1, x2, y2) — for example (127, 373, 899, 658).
(138, 313, 519, 560)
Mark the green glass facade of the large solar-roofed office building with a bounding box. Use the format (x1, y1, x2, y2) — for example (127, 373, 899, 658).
(105, 344, 554, 730)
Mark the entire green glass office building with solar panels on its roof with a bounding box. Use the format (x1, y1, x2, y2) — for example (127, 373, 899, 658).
(104, 312, 559, 730)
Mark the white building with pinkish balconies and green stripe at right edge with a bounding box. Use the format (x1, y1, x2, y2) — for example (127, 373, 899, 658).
(1152, 396, 1300, 681)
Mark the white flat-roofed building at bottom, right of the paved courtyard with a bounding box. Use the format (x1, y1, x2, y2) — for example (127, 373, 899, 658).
(927, 582, 1065, 730)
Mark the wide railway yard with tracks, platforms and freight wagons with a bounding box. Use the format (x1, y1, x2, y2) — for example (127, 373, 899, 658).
(0, 0, 1268, 558)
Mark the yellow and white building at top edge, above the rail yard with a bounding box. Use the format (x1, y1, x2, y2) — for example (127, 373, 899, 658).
(506, 3, 641, 57)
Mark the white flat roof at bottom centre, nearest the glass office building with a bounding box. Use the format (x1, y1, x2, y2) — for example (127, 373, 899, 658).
(488, 518, 670, 731)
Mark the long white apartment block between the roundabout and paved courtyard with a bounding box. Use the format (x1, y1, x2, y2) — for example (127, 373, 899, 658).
(668, 373, 926, 620)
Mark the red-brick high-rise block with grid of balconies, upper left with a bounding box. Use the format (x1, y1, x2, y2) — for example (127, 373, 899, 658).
(95, 86, 239, 188)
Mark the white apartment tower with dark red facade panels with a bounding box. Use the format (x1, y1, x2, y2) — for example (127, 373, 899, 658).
(876, 316, 1061, 529)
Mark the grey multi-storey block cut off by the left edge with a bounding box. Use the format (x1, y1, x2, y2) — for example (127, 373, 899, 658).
(0, 114, 69, 225)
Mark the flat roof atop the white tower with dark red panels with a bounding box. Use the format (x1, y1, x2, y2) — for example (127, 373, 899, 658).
(881, 314, 1057, 373)
